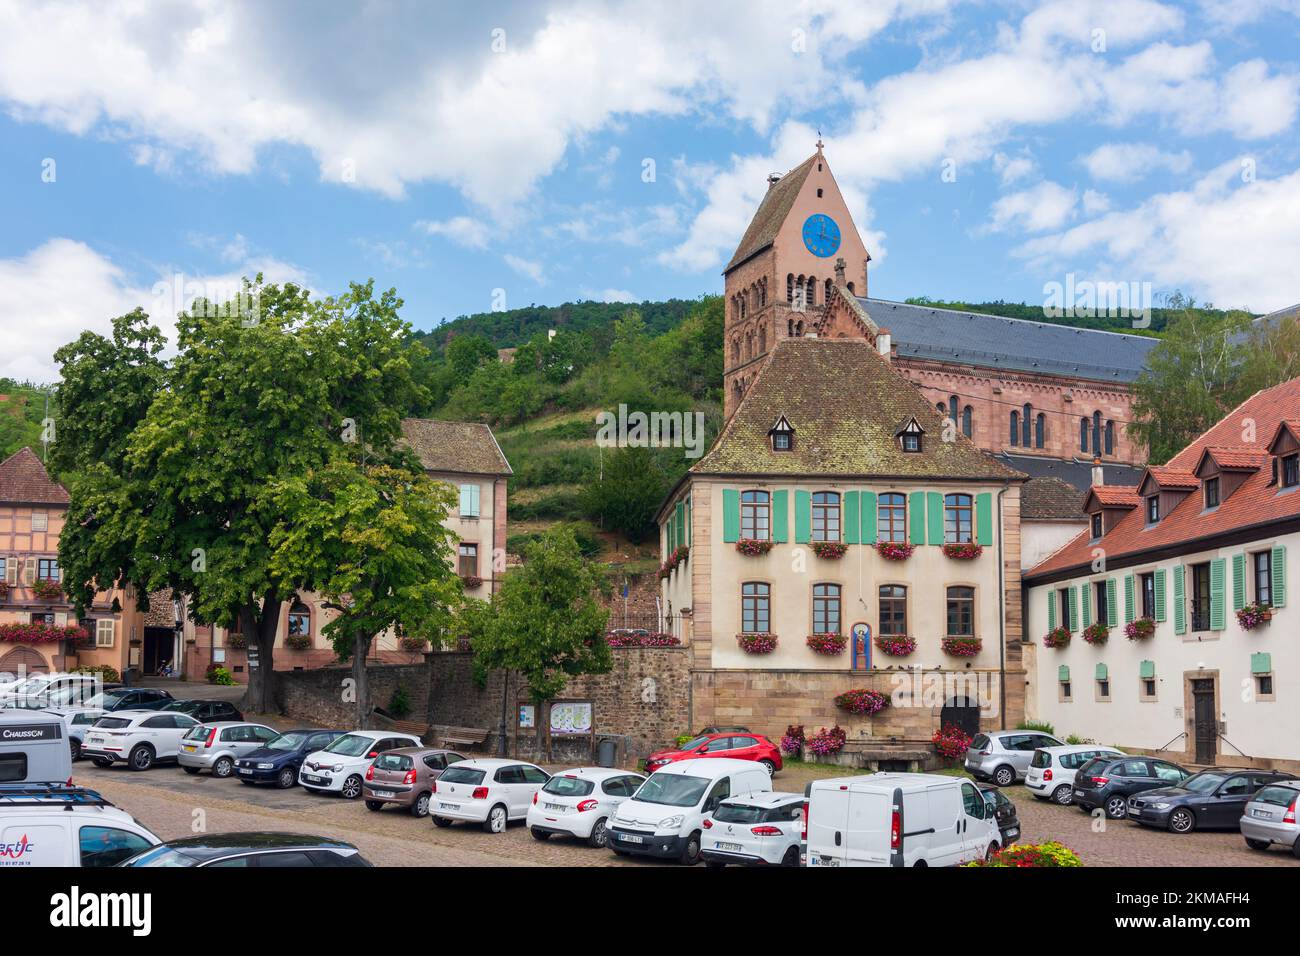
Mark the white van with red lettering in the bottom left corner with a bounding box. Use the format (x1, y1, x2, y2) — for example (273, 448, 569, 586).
(0, 785, 160, 869)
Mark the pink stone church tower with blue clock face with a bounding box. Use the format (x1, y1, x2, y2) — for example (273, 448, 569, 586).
(723, 139, 871, 418)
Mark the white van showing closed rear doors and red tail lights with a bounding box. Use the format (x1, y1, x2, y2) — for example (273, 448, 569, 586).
(803, 774, 1002, 866)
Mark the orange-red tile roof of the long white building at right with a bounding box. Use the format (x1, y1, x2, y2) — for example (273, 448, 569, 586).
(1026, 378, 1300, 580)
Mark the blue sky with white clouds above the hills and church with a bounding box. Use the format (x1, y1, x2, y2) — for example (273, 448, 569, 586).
(0, 0, 1300, 382)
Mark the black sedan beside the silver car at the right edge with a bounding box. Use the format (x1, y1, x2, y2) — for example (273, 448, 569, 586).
(1128, 767, 1295, 834)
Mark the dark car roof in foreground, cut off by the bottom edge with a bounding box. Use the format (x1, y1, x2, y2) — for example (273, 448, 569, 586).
(121, 832, 372, 869)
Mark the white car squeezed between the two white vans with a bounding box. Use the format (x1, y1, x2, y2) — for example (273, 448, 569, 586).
(699, 791, 803, 869)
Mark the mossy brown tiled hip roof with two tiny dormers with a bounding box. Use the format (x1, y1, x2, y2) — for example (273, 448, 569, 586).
(690, 338, 1024, 481)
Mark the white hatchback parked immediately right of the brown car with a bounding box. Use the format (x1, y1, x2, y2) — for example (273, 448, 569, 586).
(429, 758, 551, 834)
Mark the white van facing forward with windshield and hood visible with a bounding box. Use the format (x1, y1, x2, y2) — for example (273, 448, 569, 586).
(610, 757, 772, 866)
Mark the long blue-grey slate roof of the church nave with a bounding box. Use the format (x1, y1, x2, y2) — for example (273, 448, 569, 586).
(858, 297, 1158, 382)
